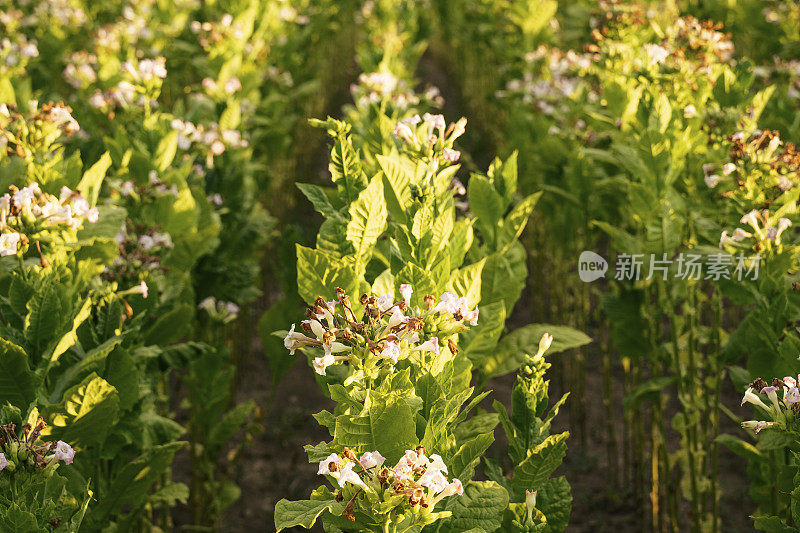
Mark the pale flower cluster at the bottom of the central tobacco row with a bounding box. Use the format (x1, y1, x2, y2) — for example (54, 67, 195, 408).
(317, 446, 464, 520)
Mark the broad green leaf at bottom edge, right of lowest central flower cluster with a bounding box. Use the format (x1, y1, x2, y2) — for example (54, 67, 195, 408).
(439, 481, 508, 533)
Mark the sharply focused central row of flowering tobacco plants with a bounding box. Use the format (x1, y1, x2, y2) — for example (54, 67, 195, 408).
(275, 2, 589, 531)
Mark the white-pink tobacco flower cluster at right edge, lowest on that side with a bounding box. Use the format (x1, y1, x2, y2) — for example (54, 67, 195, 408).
(742, 376, 800, 433)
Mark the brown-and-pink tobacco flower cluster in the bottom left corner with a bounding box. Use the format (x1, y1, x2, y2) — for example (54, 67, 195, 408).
(0, 417, 75, 473)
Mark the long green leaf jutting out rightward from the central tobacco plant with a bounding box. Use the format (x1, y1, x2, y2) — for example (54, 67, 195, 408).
(484, 324, 592, 377)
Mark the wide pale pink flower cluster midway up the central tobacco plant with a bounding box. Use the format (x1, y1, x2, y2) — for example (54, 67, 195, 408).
(284, 285, 478, 376)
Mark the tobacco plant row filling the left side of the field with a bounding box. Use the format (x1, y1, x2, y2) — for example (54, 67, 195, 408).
(0, 1, 366, 531)
